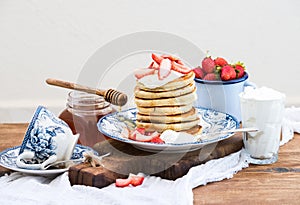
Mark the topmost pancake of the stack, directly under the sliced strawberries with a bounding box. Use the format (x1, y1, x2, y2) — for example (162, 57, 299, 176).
(137, 72, 195, 92)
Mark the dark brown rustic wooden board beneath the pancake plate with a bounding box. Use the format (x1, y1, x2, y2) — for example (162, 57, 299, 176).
(69, 134, 243, 188)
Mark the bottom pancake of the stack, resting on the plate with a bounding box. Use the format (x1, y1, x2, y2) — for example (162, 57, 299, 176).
(136, 118, 200, 133)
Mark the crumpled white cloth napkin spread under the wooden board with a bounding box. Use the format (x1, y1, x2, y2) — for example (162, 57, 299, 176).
(0, 108, 300, 205)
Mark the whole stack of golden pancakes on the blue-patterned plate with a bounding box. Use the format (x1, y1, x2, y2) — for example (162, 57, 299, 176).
(134, 72, 201, 135)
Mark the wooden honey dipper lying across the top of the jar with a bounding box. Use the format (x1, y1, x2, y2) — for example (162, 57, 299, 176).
(46, 78, 127, 106)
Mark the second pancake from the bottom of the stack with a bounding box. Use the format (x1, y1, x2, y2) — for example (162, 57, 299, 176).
(136, 108, 198, 123)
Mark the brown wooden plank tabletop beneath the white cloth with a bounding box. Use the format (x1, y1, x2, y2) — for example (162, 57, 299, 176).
(0, 124, 300, 205)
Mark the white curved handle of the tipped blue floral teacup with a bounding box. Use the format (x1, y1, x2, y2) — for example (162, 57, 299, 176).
(16, 151, 57, 170)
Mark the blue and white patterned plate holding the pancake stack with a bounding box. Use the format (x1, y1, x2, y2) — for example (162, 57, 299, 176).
(97, 108, 239, 153)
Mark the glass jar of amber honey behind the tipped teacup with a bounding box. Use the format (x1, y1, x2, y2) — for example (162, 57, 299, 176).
(59, 91, 115, 147)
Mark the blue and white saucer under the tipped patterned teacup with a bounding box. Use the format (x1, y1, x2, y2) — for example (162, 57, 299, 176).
(0, 144, 98, 176)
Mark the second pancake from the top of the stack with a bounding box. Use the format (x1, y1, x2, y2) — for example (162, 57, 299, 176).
(134, 82, 195, 99)
